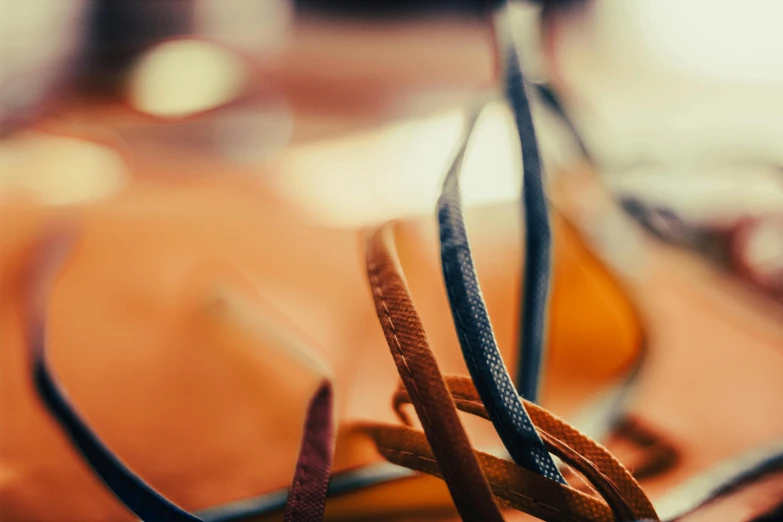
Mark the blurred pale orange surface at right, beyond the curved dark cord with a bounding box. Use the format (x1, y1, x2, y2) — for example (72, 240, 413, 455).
(552, 167, 783, 497)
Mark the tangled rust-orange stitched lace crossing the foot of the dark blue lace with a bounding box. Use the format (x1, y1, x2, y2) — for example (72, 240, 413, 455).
(365, 223, 657, 522)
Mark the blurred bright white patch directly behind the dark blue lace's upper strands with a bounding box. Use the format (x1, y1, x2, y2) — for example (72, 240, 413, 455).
(275, 99, 520, 226)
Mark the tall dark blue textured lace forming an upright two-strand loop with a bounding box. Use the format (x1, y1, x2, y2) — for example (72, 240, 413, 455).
(437, 6, 565, 483)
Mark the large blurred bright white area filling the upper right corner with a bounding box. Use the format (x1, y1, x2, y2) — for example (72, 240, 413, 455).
(554, 0, 783, 167)
